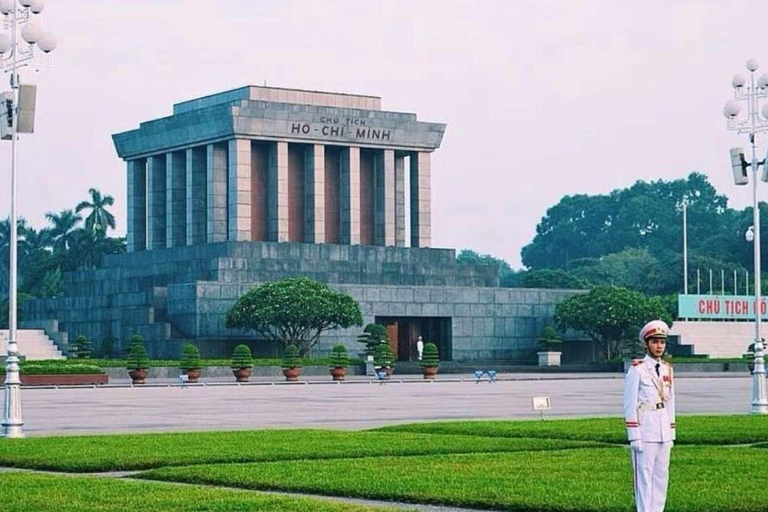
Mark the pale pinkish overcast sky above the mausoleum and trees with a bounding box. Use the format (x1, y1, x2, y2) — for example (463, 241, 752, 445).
(0, 0, 768, 267)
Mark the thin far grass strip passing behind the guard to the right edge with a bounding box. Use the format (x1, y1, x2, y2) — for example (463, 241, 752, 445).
(375, 415, 768, 446)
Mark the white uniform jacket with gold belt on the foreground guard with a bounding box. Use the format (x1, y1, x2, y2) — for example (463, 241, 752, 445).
(624, 355, 675, 443)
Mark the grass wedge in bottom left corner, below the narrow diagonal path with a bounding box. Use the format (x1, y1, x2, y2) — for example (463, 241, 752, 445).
(0, 473, 392, 512)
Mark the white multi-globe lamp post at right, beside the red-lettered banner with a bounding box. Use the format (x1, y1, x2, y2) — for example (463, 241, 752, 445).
(723, 59, 768, 414)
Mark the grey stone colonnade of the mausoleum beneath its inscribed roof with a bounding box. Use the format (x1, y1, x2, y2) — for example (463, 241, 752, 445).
(127, 139, 431, 252)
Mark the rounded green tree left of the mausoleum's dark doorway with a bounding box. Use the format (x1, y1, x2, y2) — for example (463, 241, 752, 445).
(227, 277, 363, 356)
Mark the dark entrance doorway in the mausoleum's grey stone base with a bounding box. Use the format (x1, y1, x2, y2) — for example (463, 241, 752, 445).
(376, 317, 453, 361)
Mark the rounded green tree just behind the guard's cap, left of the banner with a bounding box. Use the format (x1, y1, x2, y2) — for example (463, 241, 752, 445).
(555, 286, 672, 361)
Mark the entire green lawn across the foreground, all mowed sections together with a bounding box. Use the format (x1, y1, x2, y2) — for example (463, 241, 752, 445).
(0, 415, 768, 512)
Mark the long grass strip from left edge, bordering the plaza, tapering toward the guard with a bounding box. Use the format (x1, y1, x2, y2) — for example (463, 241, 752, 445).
(0, 430, 600, 472)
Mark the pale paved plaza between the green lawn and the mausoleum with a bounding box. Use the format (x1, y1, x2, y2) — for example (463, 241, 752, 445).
(15, 374, 752, 436)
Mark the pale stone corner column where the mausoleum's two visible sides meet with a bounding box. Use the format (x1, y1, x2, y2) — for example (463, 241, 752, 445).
(227, 139, 252, 241)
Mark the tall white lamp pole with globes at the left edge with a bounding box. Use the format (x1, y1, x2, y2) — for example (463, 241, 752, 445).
(0, 0, 56, 437)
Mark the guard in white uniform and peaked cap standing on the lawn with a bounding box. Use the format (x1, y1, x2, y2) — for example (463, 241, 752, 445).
(624, 320, 675, 512)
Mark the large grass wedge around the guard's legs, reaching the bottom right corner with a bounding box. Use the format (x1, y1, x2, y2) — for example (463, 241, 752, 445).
(140, 447, 768, 512)
